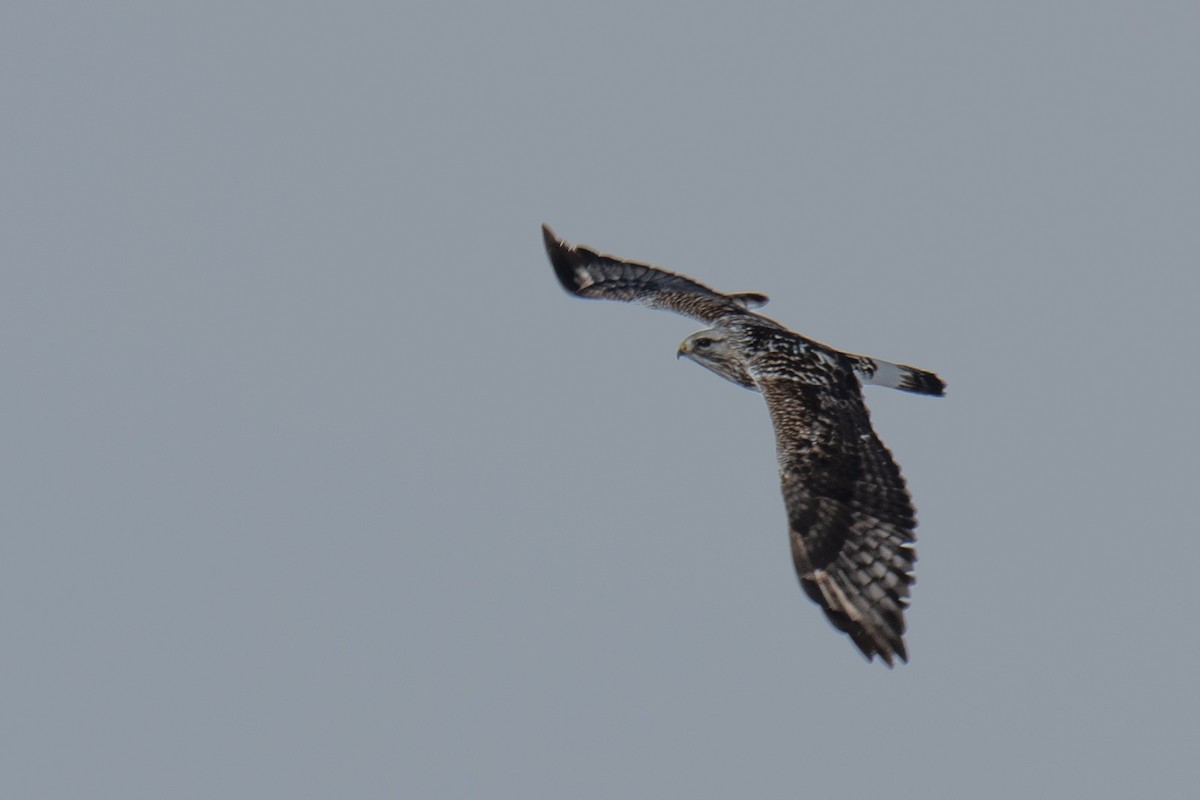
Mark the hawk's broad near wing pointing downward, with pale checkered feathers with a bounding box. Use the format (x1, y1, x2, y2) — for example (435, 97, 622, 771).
(751, 351, 917, 666)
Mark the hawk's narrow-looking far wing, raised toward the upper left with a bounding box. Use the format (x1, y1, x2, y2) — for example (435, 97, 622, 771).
(541, 225, 778, 326)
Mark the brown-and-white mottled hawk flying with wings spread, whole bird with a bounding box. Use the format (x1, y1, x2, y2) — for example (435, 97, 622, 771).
(542, 225, 946, 667)
